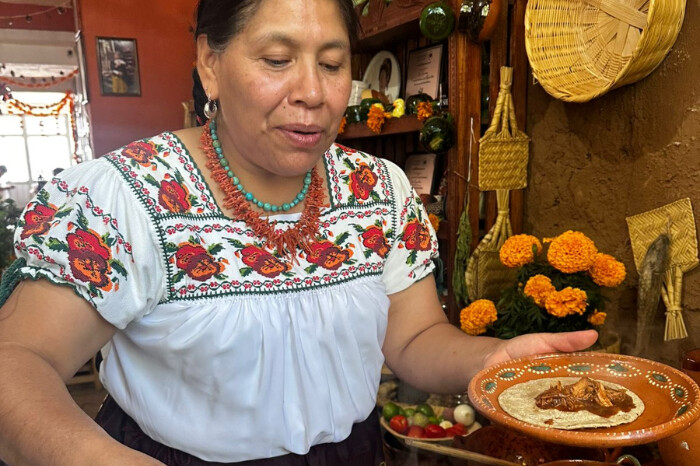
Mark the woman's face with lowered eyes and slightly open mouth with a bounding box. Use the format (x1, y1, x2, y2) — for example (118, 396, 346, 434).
(199, 0, 351, 176)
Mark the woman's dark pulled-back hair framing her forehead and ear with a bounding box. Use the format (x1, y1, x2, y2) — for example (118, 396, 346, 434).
(192, 0, 359, 122)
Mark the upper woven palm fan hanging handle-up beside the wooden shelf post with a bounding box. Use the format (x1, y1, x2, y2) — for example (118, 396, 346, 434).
(479, 66, 530, 191)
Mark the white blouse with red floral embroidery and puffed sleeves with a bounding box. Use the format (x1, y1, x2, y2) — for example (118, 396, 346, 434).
(10, 132, 437, 462)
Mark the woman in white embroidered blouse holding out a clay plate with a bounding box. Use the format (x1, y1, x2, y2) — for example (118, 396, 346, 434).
(0, 0, 595, 465)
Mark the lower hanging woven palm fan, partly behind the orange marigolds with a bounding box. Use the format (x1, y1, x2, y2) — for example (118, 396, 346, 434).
(465, 190, 517, 301)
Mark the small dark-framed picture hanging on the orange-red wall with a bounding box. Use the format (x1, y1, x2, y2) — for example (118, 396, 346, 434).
(97, 37, 141, 96)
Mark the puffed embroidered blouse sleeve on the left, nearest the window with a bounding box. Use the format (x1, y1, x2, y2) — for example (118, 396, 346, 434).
(2, 159, 164, 329)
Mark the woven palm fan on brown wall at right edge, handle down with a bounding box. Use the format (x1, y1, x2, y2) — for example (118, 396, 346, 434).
(627, 199, 700, 340)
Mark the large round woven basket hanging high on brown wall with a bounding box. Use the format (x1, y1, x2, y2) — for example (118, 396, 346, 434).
(525, 0, 686, 102)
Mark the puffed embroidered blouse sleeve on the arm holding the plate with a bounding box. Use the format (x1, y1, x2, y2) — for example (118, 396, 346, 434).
(382, 161, 438, 294)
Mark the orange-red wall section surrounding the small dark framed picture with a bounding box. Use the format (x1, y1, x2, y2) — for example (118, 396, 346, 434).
(80, 0, 196, 156)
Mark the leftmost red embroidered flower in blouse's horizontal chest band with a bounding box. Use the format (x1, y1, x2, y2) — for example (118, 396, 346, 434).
(167, 237, 228, 283)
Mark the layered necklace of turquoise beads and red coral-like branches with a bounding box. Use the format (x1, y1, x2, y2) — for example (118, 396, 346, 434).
(201, 120, 323, 258)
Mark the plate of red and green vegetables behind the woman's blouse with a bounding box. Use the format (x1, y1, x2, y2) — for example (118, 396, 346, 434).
(380, 402, 481, 442)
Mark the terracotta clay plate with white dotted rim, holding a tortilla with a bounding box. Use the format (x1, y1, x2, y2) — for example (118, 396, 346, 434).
(469, 352, 700, 448)
